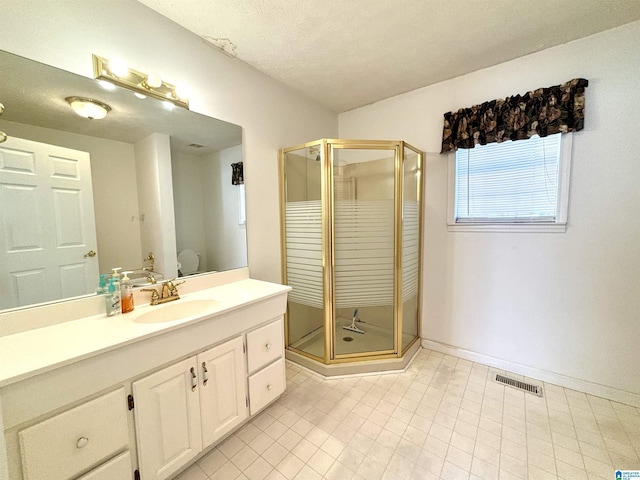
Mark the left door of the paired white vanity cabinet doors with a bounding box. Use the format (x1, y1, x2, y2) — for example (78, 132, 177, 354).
(133, 357, 202, 480)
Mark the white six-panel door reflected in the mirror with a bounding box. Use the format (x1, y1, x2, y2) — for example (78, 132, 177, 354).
(0, 137, 98, 309)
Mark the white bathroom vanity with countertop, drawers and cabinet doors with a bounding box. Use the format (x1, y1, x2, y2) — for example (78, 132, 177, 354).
(0, 268, 290, 480)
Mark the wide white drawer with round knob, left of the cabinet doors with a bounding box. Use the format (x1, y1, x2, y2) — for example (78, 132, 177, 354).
(18, 388, 129, 480)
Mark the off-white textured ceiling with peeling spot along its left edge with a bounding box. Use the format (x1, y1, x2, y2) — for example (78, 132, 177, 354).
(139, 0, 640, 112)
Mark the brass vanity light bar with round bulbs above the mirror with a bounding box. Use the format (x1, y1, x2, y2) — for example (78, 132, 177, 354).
(93, 55, 189, 110)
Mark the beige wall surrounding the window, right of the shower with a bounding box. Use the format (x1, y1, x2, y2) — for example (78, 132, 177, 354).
(340, 22, 640, 404)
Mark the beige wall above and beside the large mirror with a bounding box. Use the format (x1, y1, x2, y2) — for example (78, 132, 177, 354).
(0, 0, 338, 281)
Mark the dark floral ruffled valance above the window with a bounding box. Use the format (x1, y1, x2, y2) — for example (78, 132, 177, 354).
(441, 78, 589, 153)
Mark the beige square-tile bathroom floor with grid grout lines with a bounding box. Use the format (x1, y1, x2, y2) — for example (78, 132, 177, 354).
(178, 350, 640, 480)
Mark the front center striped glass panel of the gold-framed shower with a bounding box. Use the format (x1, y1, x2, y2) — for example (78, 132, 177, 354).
(331, 144, 395, 358)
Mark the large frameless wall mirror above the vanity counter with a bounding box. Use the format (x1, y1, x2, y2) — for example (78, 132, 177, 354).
(0, 51, 247, 310)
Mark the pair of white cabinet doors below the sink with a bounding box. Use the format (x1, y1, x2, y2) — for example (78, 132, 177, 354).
(133, 337, 247, 480)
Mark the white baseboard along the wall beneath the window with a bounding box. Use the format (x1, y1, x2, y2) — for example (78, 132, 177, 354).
(421, 338, 640, 408)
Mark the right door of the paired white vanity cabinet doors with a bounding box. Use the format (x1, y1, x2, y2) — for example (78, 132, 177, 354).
(197, 337, 247, 448)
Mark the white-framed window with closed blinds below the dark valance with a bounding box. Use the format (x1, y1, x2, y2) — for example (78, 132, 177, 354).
(448, 133, 572, 231)
